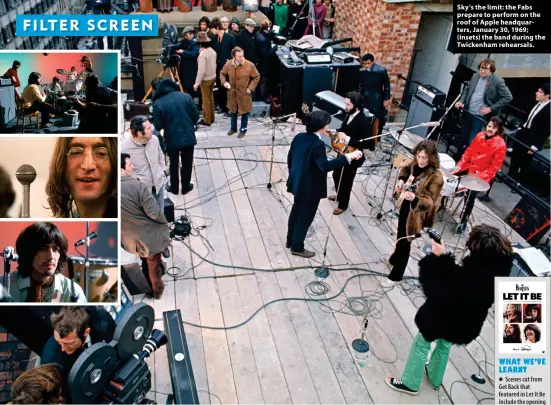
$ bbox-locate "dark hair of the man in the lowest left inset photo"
[15,222,69,277]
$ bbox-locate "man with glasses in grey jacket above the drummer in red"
[455,59,513,145]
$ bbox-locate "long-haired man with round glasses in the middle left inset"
[46,137,118,218]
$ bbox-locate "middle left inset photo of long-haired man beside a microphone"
[0,137,119,219]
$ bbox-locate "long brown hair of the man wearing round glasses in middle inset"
[46,137,119,218]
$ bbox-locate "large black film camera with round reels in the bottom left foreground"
[68,303,168,404]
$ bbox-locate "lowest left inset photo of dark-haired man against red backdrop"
[0,221,119,304]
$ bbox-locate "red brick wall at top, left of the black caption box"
[333,0,422,115]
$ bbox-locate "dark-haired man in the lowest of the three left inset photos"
[10,222,86,303]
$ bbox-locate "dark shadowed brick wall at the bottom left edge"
[0,326,31,403]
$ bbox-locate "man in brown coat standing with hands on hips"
[220,46,260,138]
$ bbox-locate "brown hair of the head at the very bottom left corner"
[11,364,65,404]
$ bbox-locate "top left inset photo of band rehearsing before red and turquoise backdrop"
[0,51,120,135]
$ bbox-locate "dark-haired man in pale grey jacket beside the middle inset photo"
[121,115,166,209]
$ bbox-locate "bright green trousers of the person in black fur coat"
[402,332,452,391]
